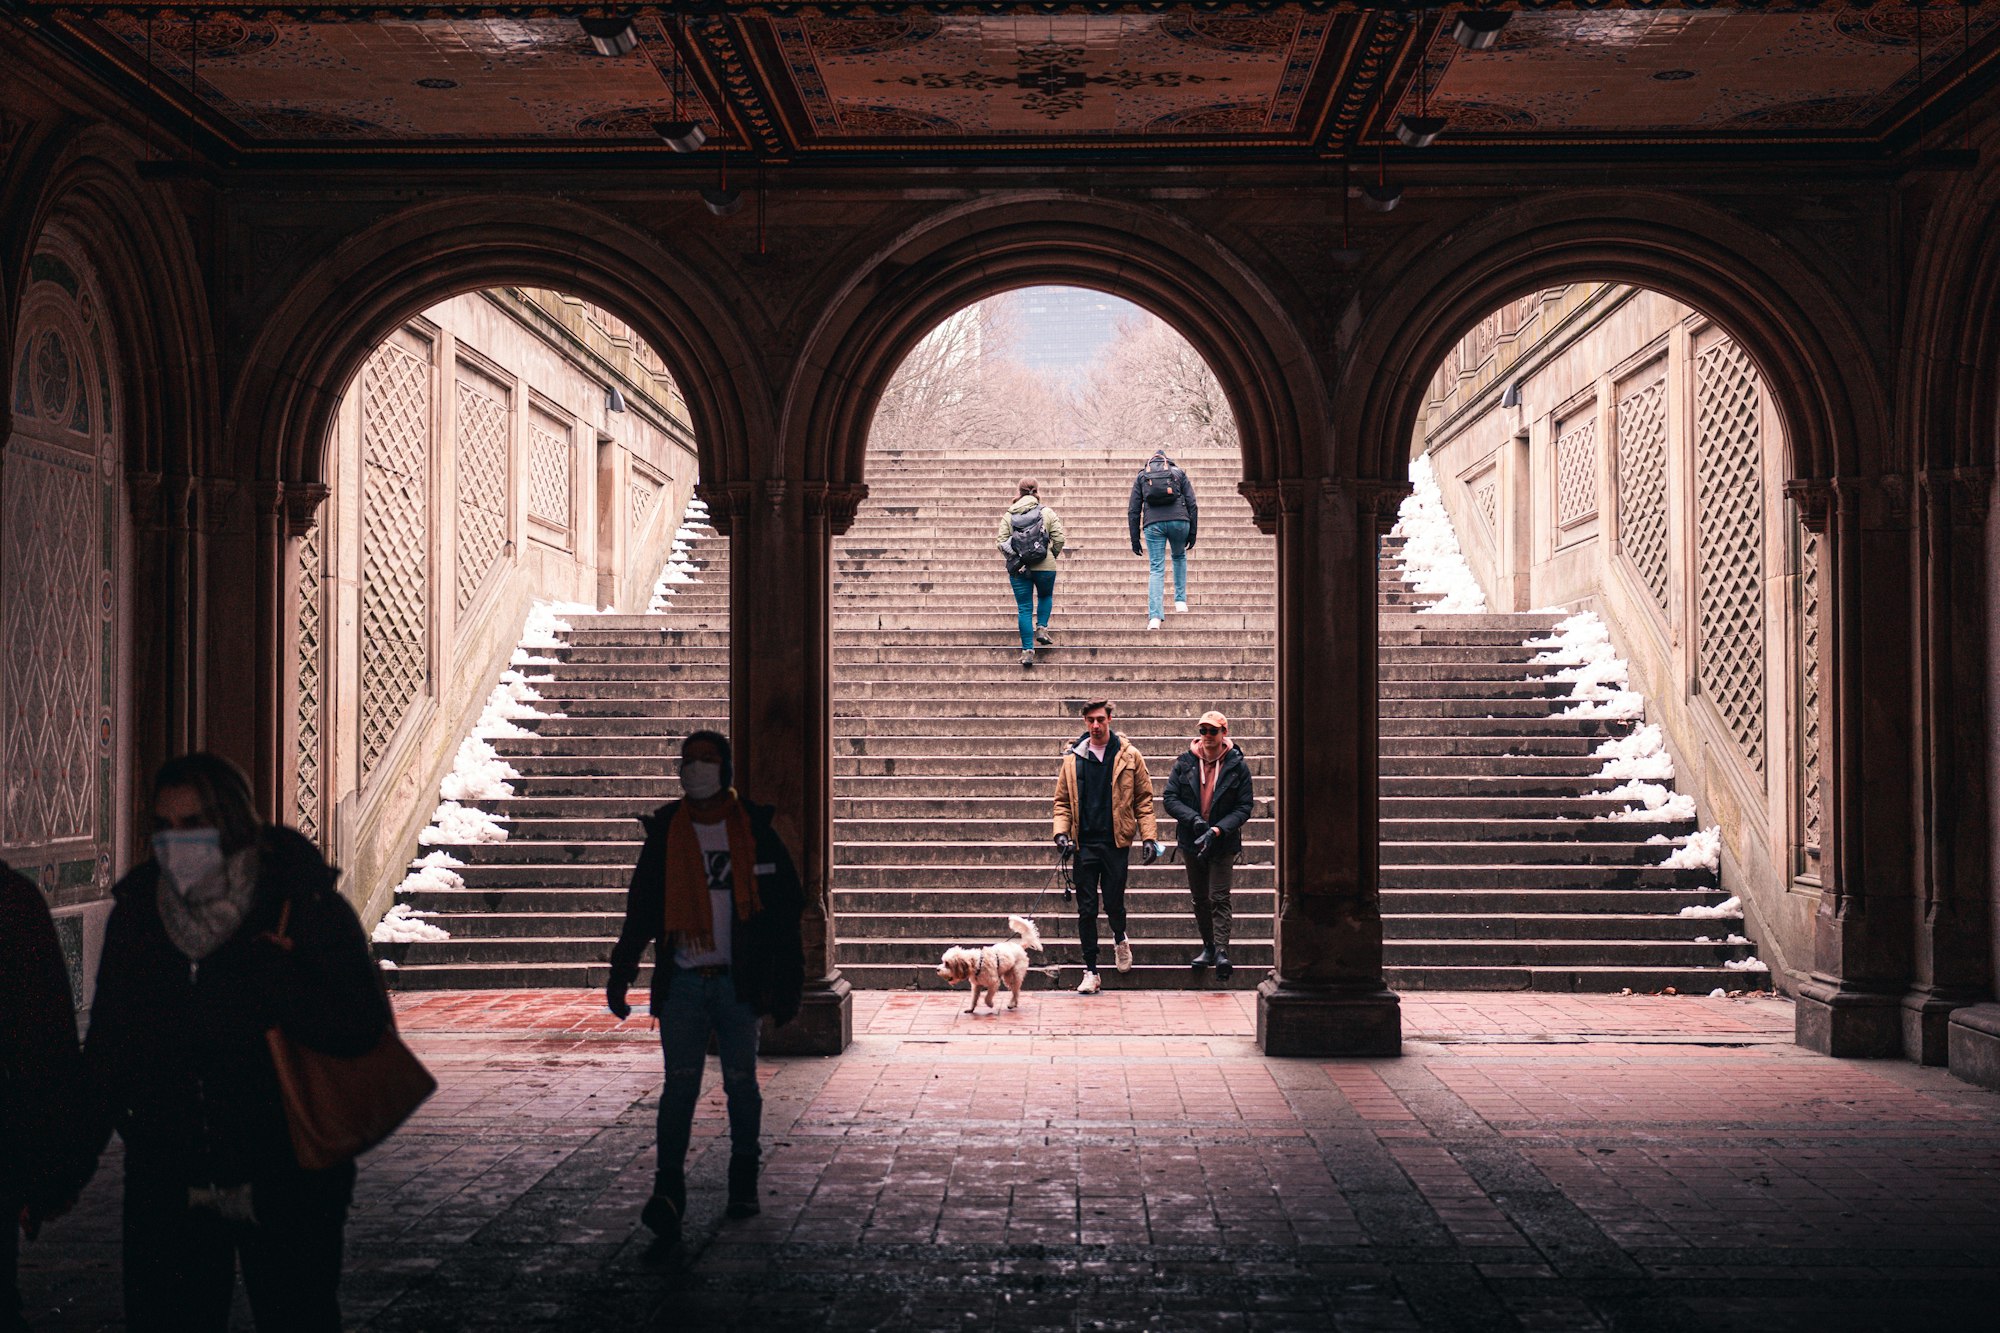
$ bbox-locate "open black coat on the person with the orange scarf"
[612,801,806,1027]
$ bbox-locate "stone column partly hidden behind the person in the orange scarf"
[696,480,866,1055]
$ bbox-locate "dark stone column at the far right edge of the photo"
[1902,468,1992,1065]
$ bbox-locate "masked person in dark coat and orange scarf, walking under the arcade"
[604,731,806,1245]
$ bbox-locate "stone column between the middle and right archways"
[1242,478,1408,1055]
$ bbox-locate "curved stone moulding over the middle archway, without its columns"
[784,194,1326,486]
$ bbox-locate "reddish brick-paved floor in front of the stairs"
[26,993,2000,1333]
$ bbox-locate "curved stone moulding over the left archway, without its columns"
[228,198,770,484]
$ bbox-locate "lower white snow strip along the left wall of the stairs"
[372,602,592,945]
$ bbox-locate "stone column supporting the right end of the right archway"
[1790,478,1914,1057]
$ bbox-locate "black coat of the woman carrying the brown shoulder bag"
[84,827,390,1185]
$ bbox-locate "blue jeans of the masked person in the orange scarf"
[654,961,764,1201]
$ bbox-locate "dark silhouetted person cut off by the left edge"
[0,861,92,1333]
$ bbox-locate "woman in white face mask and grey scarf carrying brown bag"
[84,755,390,1331]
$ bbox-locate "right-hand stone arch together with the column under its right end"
[1336,196,1912,1055]
